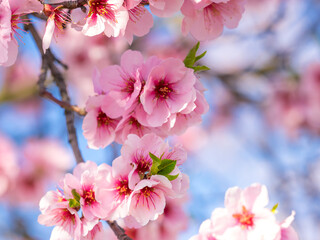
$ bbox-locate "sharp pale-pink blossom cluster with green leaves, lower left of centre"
[38,134,189,240]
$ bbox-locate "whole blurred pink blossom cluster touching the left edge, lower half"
[0,135,72,205]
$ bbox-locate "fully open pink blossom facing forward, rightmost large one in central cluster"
[140,58,196,127]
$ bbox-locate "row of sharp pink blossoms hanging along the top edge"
[0,0,248,66]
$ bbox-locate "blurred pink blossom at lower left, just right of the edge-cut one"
[8,139,73,204]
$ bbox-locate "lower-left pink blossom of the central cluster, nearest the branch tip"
[82,95,122,149]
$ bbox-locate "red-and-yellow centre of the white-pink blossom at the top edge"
[88,0,117,22]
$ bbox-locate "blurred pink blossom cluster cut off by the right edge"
[266,62,320,137]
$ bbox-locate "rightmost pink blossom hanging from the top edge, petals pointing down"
[181,0,245,41]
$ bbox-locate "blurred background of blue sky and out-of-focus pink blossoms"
[0,0,320,240]
